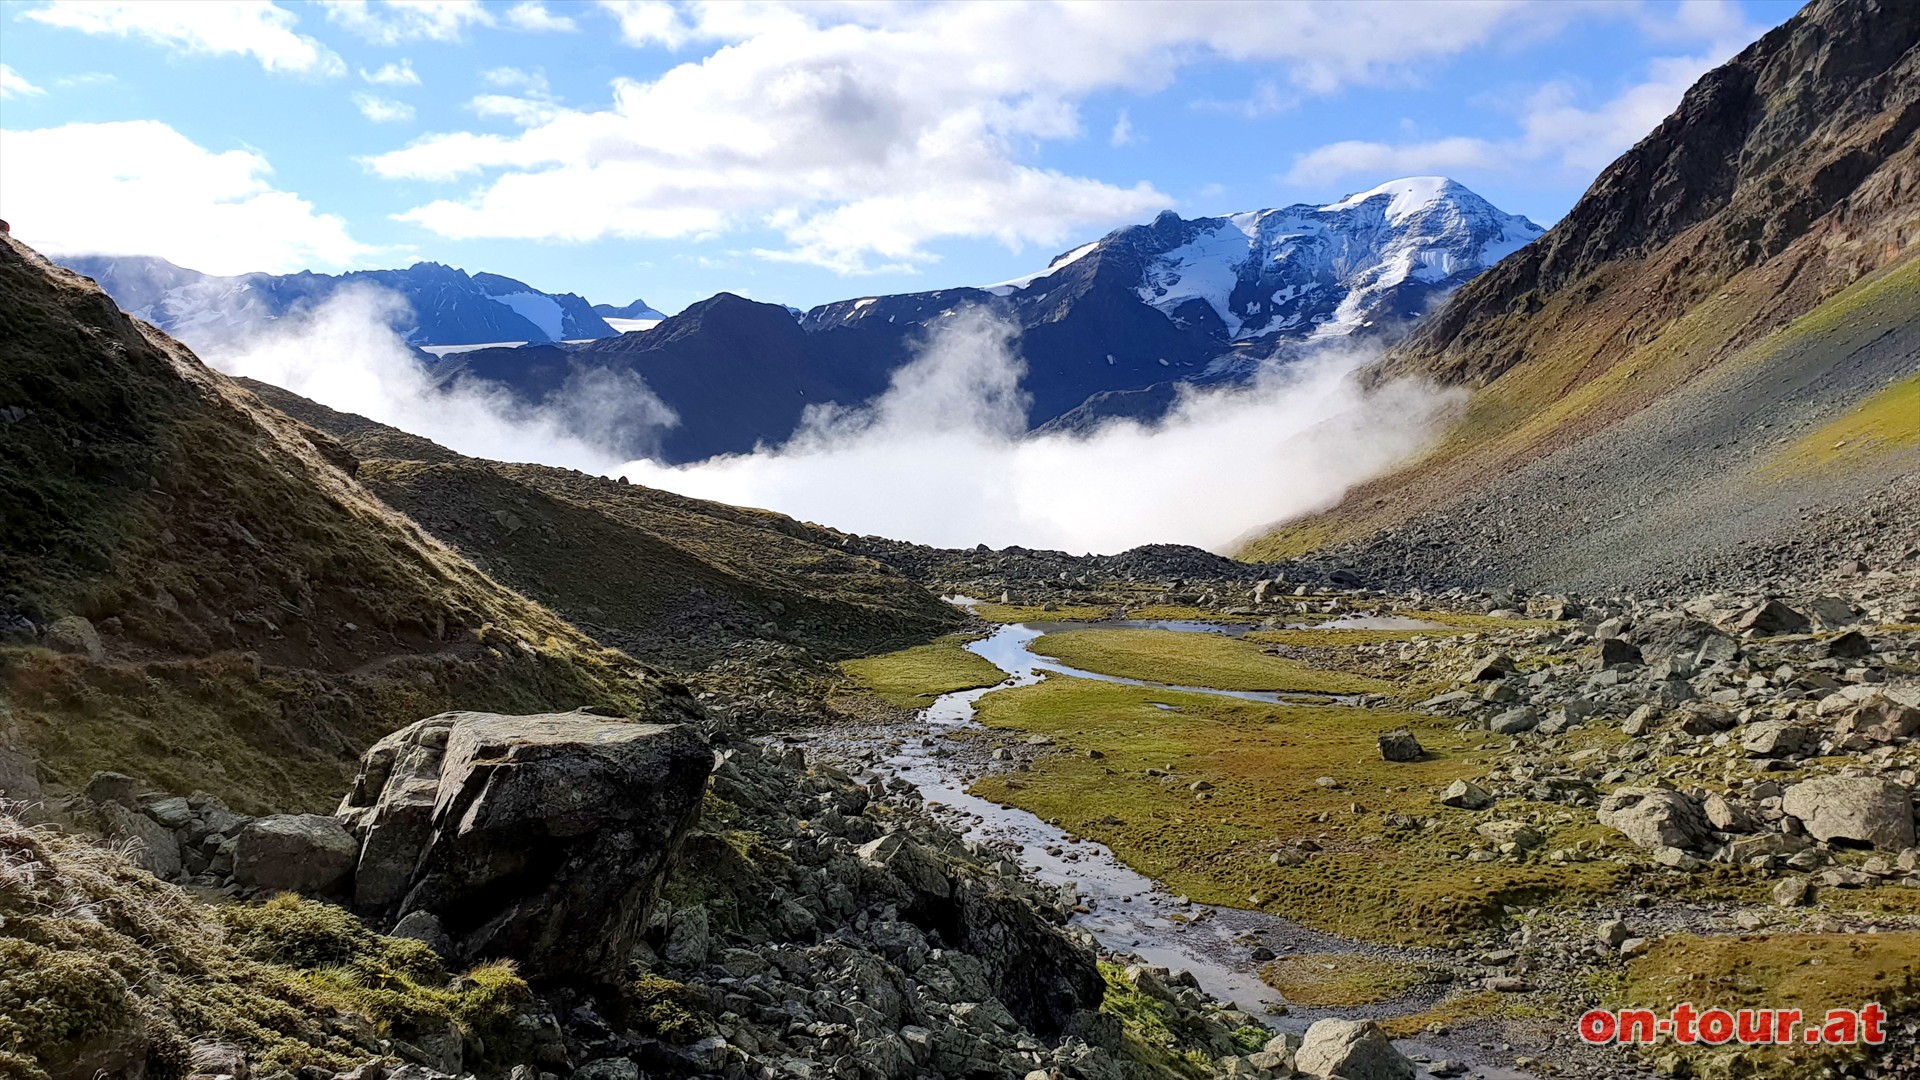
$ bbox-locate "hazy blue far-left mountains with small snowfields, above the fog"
[61,256,618,348]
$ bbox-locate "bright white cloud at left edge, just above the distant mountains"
[0,121,367,275]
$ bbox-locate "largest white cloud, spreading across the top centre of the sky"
[369,0,1563,273]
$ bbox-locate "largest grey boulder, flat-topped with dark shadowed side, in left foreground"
[340,711,714,984]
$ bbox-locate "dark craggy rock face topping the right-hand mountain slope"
[1402,0,1920,380]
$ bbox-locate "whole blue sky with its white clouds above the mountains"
[0,0,1795,311]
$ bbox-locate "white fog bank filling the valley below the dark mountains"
[196,288,1459,552]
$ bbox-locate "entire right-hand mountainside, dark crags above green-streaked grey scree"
[1242,2,1920,588]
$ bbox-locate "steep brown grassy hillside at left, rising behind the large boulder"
[0,238,691,809]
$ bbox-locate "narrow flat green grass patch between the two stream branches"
[1029,630,1392,694]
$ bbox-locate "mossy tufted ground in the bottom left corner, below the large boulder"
[0,817,530,1078]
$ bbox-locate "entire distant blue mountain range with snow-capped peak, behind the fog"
[69,177,1542,461]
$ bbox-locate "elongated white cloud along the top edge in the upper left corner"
[21,0,346,75]
